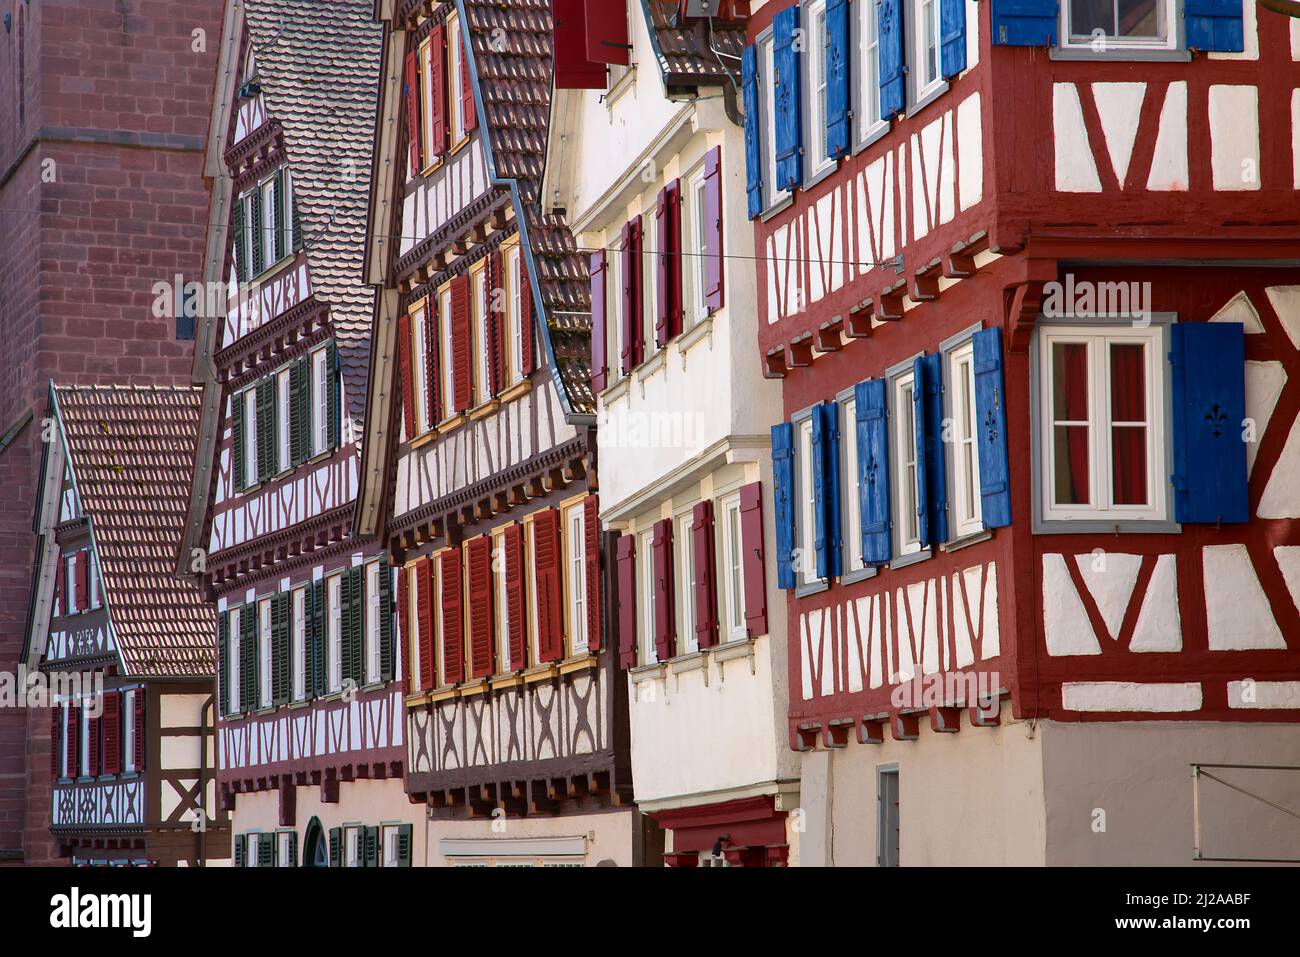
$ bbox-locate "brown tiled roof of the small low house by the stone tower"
[55,386,216,677]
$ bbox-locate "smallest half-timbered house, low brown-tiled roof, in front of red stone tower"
[22,386,230,866]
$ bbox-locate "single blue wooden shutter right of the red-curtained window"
[1170,322,1249,523]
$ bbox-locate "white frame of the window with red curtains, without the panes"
[1035,320,1171,527]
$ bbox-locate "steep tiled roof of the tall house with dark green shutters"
[243,0,384,421]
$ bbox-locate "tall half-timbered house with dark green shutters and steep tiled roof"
[178,0,423,866]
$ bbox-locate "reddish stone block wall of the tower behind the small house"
[0,0,224,863]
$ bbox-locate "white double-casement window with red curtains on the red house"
[1037,325,1169,521]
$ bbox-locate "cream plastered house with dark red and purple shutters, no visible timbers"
[542,0,798,866]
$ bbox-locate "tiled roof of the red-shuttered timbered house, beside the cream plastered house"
[464,0,595,415]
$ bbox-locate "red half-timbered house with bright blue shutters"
[744,0,1300,865]
